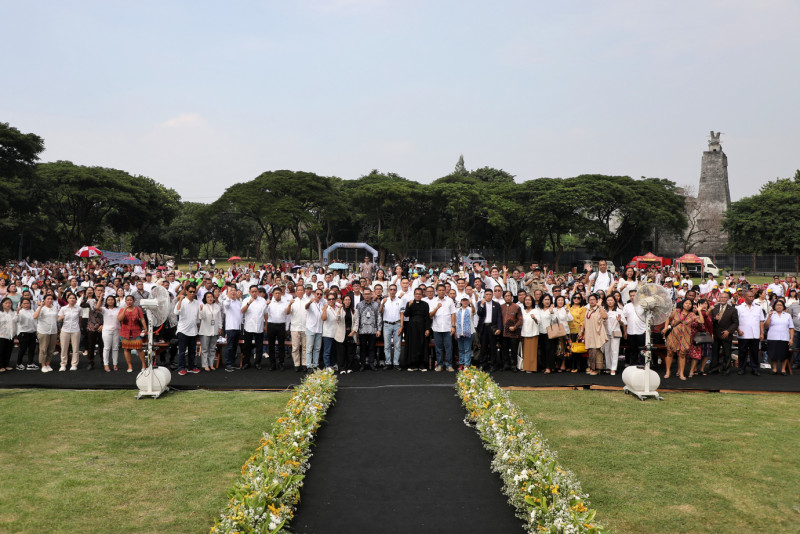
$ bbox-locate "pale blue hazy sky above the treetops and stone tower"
[0,0,800,202]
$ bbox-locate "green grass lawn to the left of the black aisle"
[0,390,290,533]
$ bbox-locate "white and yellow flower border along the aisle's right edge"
[457,369,608,533]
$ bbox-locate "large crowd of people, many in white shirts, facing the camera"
[0,257,800,380]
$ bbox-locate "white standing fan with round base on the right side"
[622,284,672,400]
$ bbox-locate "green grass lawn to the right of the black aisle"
[511,391,800,533]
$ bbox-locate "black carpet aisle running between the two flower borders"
[292,388,523,534]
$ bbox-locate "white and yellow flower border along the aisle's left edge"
[211,369,336,534]
